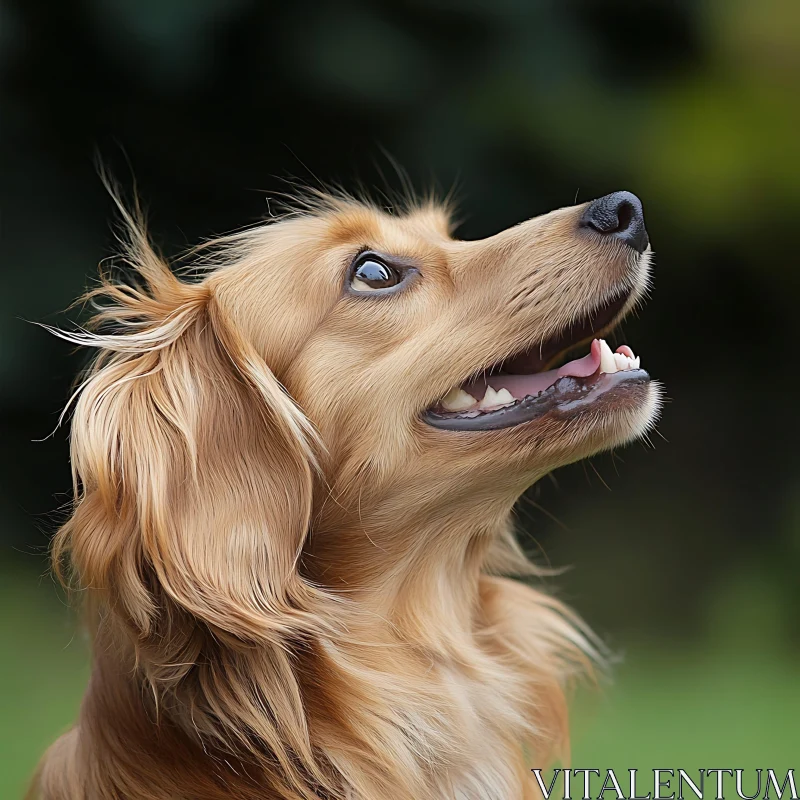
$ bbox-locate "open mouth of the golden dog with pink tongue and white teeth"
[422,292,650,431]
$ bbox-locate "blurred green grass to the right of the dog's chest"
[572,642,800,776]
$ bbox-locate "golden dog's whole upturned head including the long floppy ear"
[53,193,658,636]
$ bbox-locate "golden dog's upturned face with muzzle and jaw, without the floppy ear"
[210,192,658,523]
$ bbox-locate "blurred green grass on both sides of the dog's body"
[0,572,800,798]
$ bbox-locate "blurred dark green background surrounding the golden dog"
[0,0,800,798]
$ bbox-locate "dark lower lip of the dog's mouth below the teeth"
[422,369,650,431]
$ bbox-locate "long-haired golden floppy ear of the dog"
[55,219,324,646]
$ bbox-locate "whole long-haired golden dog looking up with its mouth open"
[31,192,659,800]
